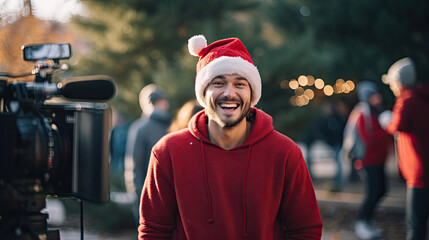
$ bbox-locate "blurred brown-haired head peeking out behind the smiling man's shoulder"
[168,100,204,133]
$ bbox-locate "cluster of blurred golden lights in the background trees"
[280,75,355,107]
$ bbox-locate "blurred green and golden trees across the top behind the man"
[0,0,429,138]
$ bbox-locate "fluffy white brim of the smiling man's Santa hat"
[195,56,262,108]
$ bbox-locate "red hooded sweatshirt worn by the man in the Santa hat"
[139,108,322,240]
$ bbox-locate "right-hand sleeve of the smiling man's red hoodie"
[281,147,322,239]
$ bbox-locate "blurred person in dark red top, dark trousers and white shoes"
[343,80,392,239]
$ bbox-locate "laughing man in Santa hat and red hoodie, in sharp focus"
[138,35,322,240]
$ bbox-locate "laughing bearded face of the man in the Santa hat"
[204,74,252,128]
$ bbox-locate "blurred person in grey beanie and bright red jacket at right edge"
[384,58,429,240]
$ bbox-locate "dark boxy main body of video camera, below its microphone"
[0,102,111,202]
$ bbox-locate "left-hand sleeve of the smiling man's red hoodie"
[138,153,178,240]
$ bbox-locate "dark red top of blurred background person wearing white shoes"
[357,109,392,167]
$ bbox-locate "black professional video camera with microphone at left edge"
[0,43,116,239]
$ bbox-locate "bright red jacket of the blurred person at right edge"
[387,85,429,188]
